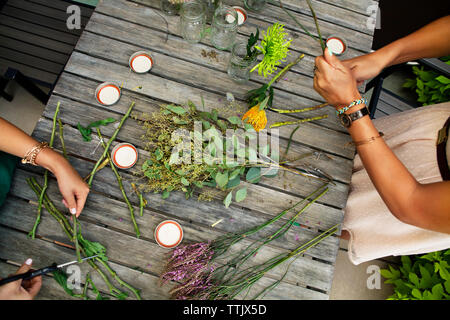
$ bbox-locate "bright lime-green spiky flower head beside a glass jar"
[251,23,292,78]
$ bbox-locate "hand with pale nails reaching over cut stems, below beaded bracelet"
[36,149,89,217]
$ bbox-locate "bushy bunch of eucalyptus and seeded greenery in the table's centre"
[137,102,278,207]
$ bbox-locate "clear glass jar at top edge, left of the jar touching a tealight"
[180,0,206,43]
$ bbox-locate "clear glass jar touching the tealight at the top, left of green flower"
[211,6,238,50]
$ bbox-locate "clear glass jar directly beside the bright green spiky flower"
[228,42,256,83]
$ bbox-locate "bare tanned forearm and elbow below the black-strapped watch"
[349,110,450,233]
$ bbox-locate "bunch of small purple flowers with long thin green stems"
[161,185,330,299]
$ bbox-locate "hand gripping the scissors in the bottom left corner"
[0,259,42,300]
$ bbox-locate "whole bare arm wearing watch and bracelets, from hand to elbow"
[314,49,450,233]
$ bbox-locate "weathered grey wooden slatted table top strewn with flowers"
[0,0,373,299]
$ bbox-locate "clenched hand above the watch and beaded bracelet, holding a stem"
[314,48,361,109]
